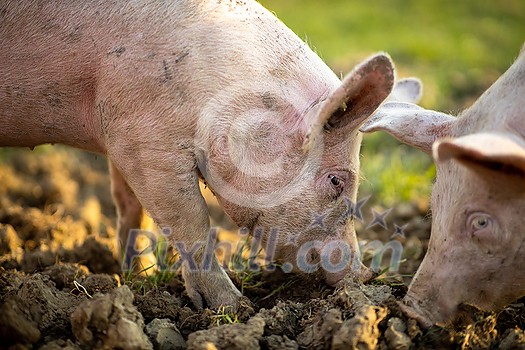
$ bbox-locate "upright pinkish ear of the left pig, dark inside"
[303,54,395,149]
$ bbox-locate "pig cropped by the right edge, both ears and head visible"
[362,43,525,326]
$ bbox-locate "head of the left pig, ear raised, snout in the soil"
[198,54,419,285]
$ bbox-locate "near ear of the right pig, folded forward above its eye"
[433,133,525,175]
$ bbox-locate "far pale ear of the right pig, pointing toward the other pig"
[360,102,456,154]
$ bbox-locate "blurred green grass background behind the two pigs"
[259,0,525,206]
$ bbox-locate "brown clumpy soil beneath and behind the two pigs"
[0,146,525,350]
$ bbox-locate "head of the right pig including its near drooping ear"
[412,131,525,326]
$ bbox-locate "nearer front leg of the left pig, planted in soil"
[108,145,241,308]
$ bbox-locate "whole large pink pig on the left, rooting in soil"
[0,0,414,307]
